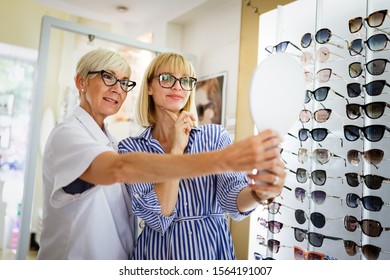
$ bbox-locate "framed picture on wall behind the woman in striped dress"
[195,72,227,124]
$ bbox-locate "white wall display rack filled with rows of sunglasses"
[248,0,390,260]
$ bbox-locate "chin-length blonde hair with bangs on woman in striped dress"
[137,53,198,127]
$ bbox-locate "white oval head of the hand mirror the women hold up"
[249,53,306,135]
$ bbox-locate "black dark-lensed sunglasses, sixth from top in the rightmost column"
[344,124,390,142]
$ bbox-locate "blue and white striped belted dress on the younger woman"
[119,124,251,260]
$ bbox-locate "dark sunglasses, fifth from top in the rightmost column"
[345,101,390,120]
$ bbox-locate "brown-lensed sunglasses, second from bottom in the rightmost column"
[344,215,390,237]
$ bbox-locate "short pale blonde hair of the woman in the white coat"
[76,49,131,80]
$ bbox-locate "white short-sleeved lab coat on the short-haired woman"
[38,107,136,260]
